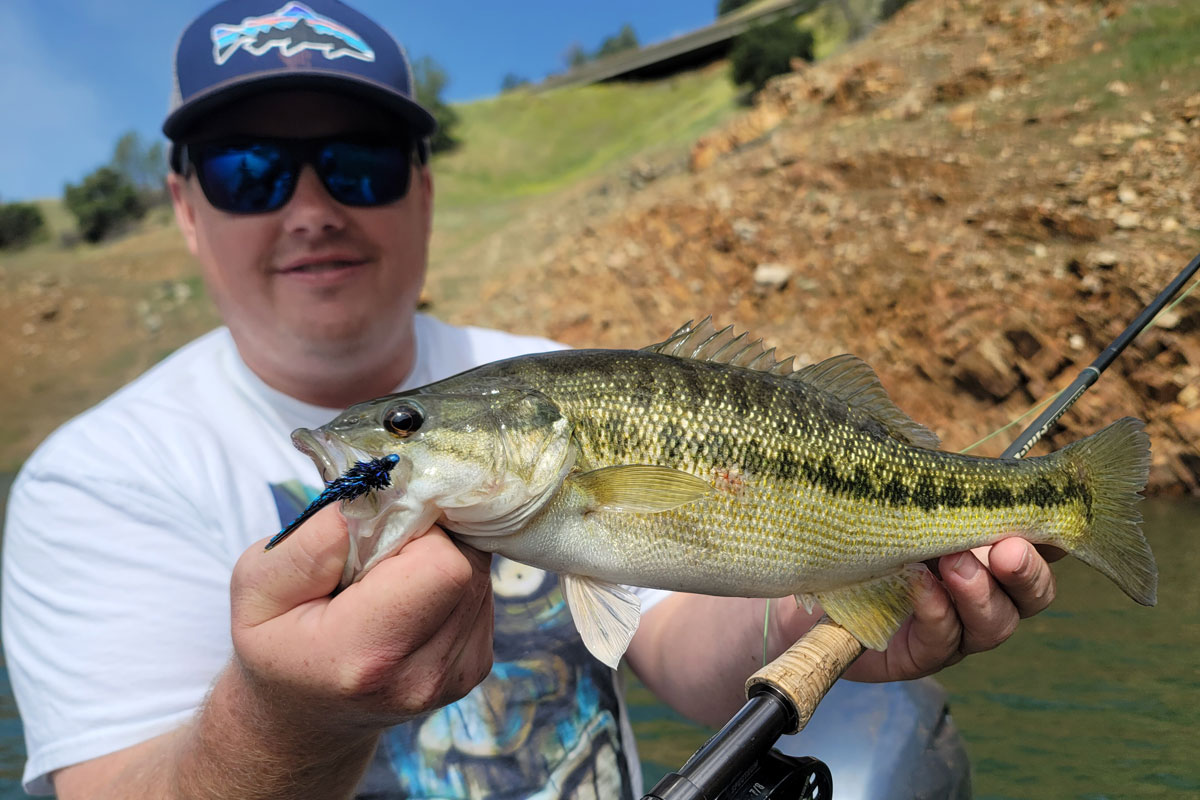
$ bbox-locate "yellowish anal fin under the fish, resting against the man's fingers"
[816,564,926,650]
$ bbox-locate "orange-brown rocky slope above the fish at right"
[457,0,1200,494]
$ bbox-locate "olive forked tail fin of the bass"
[1062,416,1158,606]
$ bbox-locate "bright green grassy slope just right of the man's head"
[430,62,740,302]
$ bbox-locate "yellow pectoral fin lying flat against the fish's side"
[568,464,713,513]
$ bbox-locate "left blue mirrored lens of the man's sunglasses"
[198,144,295,213]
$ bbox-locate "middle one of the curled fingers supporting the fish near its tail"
[938,552,1020,654]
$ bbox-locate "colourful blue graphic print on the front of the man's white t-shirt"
[271,481,632,800]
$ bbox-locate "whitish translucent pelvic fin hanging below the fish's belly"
[563,575,642,669]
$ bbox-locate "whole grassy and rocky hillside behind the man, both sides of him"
[0,0,1200,493]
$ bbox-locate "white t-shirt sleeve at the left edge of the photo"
[2,447,232,794]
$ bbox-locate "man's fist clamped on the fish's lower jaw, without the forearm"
[232,509,492,728]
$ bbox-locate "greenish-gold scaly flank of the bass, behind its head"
[484,351,1082,594]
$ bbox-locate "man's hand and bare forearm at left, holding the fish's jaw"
[54,507,492,800]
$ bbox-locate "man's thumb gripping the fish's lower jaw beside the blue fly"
[230,506,350,626]
